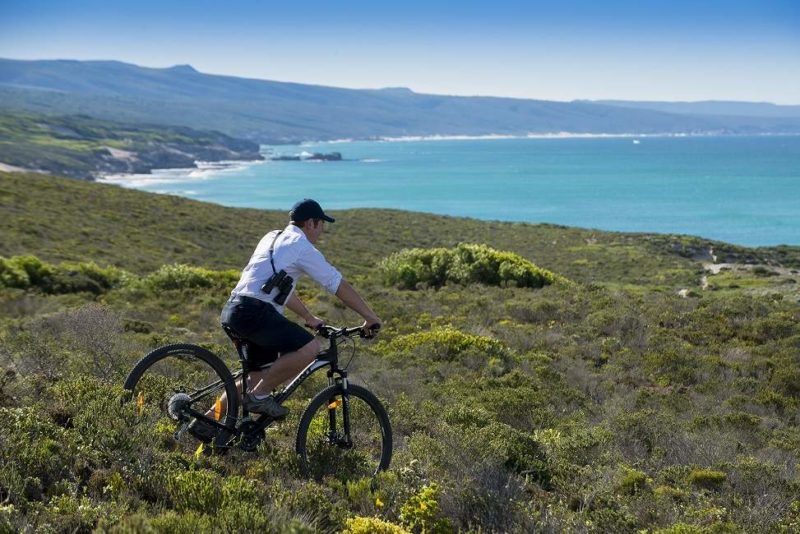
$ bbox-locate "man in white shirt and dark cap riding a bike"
[189,198,381,441]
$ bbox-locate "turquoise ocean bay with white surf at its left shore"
[100,136,800,246]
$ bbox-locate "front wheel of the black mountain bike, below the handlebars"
[296,384,392,480]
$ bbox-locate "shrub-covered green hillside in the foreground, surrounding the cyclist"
[0,173,800,534]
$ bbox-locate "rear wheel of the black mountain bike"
[124,343,239,449]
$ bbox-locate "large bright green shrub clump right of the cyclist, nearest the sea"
[380,243,565,289]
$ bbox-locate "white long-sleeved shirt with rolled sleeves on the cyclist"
[231,224,342,313]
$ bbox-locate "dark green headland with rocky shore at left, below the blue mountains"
[0,111,263,179]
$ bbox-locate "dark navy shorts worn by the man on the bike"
[219,295,314,367]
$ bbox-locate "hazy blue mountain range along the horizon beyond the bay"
[0,59,800,143]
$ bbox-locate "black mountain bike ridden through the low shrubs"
[124,325,392,484]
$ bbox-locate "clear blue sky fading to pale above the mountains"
[0,0,800,105]
